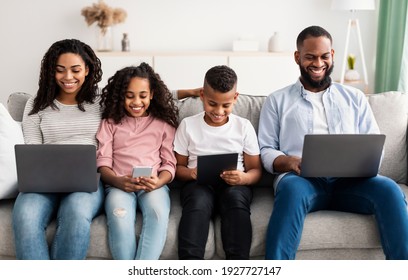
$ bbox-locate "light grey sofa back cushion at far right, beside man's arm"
[368,92,408,184]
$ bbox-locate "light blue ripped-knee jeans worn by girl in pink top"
[105,185,170,260]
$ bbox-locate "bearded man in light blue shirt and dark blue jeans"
[258,26,408,259]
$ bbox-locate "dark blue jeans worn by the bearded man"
[265,173,408,259]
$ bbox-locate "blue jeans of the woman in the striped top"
[13,183,104,260]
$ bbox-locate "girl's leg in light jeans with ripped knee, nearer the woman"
[105,187,137,260]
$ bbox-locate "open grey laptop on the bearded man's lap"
[300,134,385,177]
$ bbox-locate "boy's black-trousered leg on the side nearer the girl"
[178,182,214,260]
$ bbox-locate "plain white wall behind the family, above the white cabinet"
[0,0,378,104]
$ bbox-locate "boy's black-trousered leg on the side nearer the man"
[219,186,252,260]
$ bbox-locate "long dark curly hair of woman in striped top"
[30,39,102,115]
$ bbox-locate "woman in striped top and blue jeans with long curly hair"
[13,39,104,259]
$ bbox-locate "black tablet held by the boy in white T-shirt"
[197,153,238,185]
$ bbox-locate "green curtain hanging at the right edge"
[375,0,408,93]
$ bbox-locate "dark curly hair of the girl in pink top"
[100,62,178,127]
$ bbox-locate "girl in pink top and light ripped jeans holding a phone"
[97,63,178,259]
